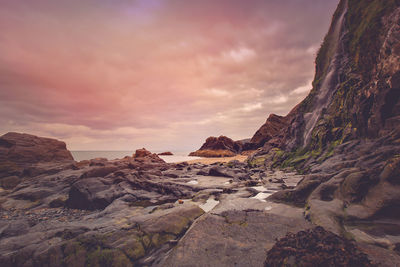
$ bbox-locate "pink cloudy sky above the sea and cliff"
[0,0,339,151]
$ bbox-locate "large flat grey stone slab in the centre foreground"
[154,198,312,266]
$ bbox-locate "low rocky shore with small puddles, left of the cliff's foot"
[0,133,400,266]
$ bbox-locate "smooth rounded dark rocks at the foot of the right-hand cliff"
[260,132,400,266]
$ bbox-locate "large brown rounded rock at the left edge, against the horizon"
[0,132,74,165]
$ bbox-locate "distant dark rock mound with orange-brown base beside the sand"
[189,135,243,157]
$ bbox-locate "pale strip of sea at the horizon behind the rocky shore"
[71,151,200,163]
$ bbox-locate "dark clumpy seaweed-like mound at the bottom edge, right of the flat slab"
[265,227,374,267]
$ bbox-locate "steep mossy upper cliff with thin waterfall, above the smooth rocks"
[252,0,400,164]
